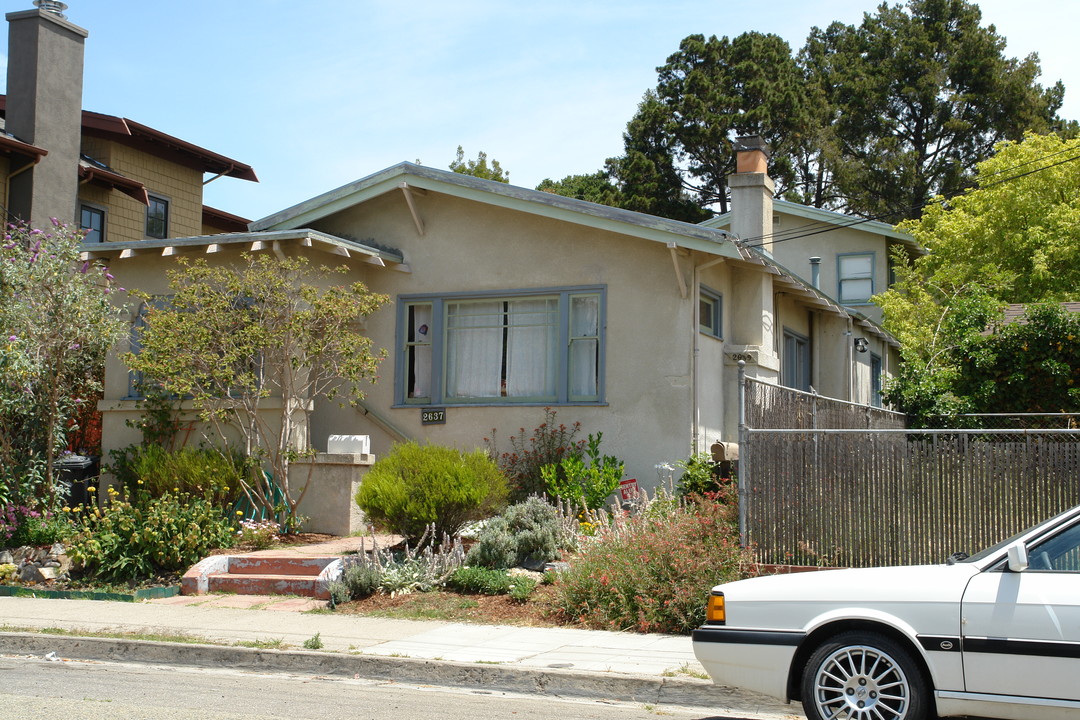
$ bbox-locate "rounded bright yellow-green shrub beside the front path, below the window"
[356,443,507,541]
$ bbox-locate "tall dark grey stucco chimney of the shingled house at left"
[5,0,90,228]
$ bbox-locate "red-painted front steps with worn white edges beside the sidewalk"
[180,555,342,600]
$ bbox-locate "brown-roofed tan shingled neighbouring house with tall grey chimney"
[0,3,257,243]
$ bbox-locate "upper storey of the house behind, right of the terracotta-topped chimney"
[702,179,924,323]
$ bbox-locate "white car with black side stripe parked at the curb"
[693,507,1080,720]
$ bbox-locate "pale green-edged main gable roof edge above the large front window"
[251,162,740,258]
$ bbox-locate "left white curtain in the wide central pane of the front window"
[446,301,503,397]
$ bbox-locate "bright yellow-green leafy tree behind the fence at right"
[877,134,1080,417]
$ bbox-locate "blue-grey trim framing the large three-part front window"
[394,285,607,408]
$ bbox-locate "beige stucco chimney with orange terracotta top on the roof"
[728,135,777,254]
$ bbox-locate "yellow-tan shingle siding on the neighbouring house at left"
[79,138,203,242]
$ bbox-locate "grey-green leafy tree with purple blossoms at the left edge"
[0,222,124,501]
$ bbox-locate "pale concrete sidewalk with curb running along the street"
[0,596,801,718]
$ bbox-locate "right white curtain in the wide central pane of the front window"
[507,298,558,398]
